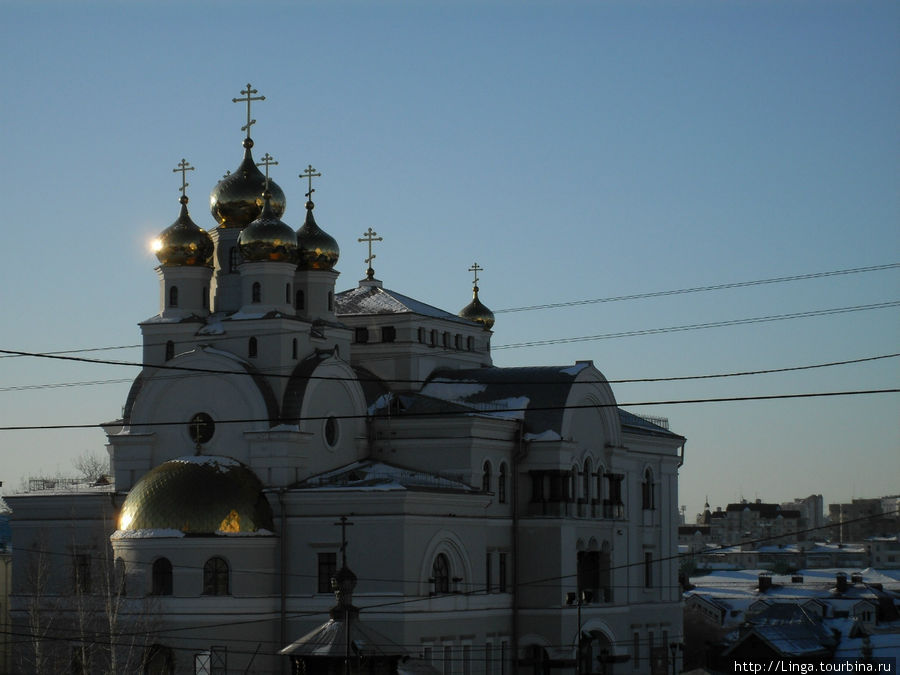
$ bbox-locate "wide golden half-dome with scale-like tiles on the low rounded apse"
[119,456,274,534]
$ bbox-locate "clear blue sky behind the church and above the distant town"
[0,0,900,518]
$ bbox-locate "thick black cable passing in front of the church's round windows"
[0,388,900,431]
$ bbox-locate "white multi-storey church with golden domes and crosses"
[6,85,685,675]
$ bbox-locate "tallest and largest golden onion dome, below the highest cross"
[209,138,285,228]
